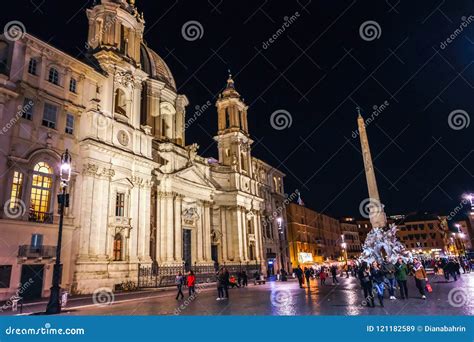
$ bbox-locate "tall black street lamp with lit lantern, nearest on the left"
[46,149,72,314]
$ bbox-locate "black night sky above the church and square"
[0,0,474,216]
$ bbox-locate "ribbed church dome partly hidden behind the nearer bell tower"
[140,44,176,90]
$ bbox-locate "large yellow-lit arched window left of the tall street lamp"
[29,162,53,223]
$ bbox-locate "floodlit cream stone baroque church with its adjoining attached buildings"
[0,0,289,299]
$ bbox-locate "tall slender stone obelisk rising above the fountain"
[357,107,387,228]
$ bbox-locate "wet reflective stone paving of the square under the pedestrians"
[50,273,474,315]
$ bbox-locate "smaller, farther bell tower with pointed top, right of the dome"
[214,73,253,177]
